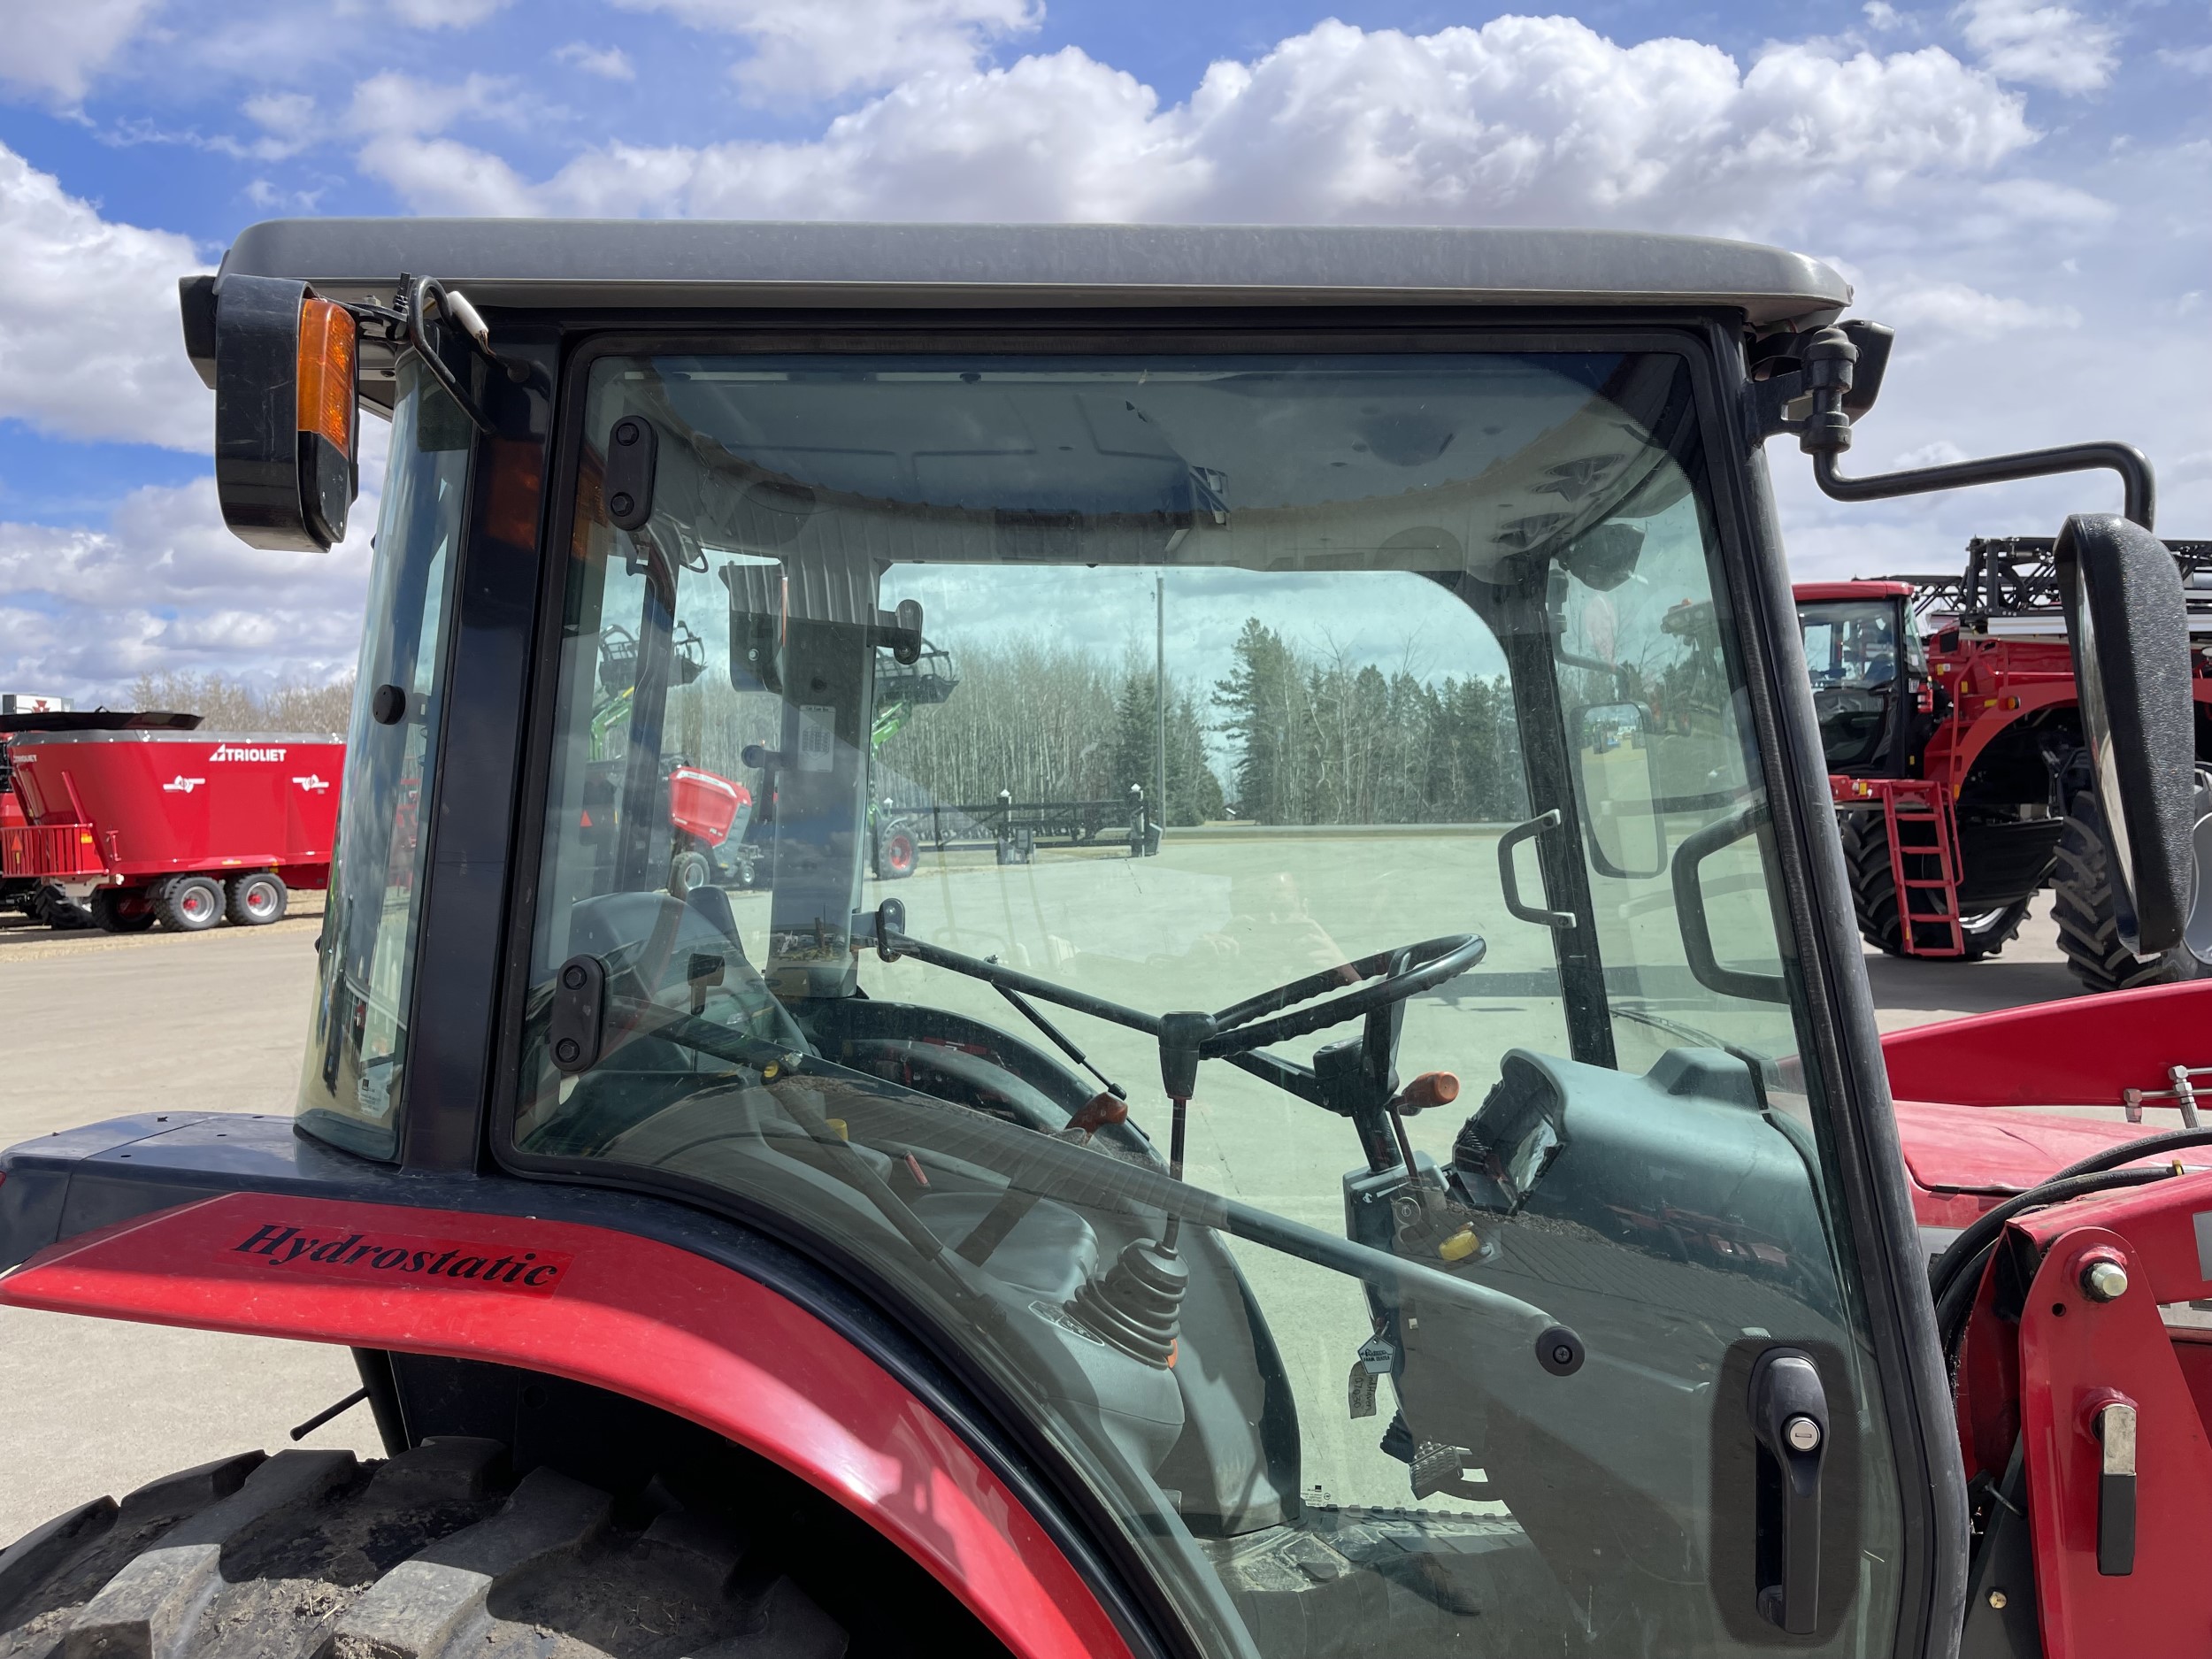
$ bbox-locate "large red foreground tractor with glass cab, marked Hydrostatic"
[0,219,2212,1659]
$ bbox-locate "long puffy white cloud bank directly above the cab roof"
[363,18,2035,233]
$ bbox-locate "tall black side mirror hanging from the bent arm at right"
[2051,513,2197,956]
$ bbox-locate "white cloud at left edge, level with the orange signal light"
[0,144,215,449]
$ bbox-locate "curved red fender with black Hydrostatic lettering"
[0,1193,1131,1659]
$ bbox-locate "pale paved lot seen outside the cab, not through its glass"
[0,885,2073,1544]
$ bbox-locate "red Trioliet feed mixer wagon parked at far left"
[0,730,345,933]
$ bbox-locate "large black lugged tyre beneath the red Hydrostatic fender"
[0,1438,849,1659]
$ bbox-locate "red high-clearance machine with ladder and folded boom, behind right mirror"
[1796,535,2212,991]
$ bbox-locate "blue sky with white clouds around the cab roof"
[0,0,2212,699]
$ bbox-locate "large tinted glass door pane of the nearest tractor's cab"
[511,352,1893,1655]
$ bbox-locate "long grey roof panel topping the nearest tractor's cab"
[224,219,1852,323]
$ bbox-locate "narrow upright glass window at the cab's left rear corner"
[299,358,472,1157]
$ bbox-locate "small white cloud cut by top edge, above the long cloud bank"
[615,0,1044,102]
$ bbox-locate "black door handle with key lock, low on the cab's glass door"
[1750,1348,1827,1637]
